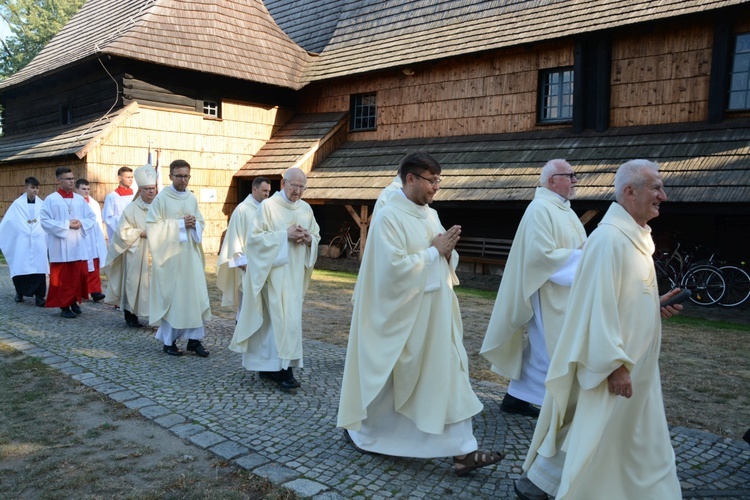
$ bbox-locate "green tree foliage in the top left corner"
[0,0,86,78]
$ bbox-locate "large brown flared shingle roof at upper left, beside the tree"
[0,0,309,89]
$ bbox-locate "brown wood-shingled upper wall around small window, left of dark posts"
[300,41,574,140]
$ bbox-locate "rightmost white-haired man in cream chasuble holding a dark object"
[515,160,682,500]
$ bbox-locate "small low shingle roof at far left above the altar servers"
[0,103,138,163]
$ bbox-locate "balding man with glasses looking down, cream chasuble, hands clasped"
[229,168,320,391]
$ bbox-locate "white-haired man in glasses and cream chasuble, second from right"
[481,160,586,417]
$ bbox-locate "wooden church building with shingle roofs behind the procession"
[0,0,750,259]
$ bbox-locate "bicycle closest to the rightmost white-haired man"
[654,243,726,306]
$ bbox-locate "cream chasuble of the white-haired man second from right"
[481,187,586,379]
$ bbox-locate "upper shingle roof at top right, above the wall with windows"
[302,0,747,81]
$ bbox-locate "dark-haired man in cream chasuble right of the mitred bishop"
[146,160,211,357]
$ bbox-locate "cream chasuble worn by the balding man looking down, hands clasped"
[229,191,320,370]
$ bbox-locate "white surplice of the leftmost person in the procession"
[0,193,49,278]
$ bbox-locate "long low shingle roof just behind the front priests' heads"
[305,119,750,203]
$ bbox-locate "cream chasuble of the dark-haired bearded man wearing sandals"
[337,195,482,440]
